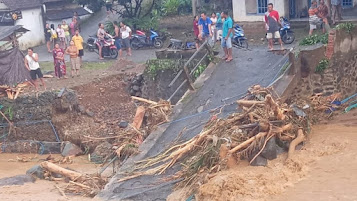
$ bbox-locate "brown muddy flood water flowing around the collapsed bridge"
[0,112,357,201]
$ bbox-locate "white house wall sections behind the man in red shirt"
[233,0,289,22]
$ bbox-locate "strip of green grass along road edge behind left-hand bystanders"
[40,61,114,72]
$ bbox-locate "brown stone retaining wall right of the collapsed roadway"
[289,29,357,102]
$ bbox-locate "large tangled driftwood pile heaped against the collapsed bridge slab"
[120,86,308,189]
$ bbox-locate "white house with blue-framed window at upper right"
[232,0,357,22]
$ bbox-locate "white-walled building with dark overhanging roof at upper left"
[0,0,91,49]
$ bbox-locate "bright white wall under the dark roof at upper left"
[15,8,45,49]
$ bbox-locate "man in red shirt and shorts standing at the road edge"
[265,3,284,50]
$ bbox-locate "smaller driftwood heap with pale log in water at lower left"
[41,161,107,197]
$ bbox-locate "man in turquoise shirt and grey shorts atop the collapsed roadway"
[221,11,233,62]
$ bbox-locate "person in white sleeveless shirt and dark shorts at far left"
[25,48,46,91]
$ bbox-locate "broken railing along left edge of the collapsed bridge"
[168,40,213,101]
